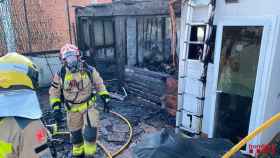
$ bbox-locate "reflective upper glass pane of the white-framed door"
[218,26,263,97]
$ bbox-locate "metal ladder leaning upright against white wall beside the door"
[176,0,216,135]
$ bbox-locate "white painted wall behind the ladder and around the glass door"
[180,0,280,143]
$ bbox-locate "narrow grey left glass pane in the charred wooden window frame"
[93,20,104,46]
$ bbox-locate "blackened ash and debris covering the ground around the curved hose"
[38,89,175,158]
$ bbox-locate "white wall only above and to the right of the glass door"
[215,0,280,148]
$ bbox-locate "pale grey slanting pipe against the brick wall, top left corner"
[0,0,17,52]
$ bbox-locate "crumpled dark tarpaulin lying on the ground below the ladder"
[133,129,245,158]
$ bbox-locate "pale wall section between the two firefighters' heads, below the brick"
[29,54,61,87]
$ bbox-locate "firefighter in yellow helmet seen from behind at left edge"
[0,53,51,158]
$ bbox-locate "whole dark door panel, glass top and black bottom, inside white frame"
[214,26,263,143]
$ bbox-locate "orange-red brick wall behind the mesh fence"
[0,0,112,53]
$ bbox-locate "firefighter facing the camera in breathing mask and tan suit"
[49,44,110,158]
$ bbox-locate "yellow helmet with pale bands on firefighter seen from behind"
[0,53,39,89]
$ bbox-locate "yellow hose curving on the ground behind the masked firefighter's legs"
[46,108,133,158]
